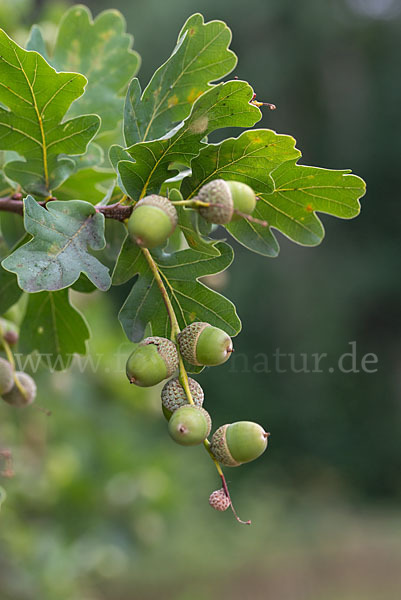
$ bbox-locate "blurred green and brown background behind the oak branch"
[0,0,401,600]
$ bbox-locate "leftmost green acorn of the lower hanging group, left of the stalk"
[126,336,178,387]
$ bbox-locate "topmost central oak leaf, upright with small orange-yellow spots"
[124,14,237,146]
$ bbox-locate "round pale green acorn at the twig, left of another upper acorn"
[127,194,178,248]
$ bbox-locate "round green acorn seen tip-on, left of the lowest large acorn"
[168,404,212,446]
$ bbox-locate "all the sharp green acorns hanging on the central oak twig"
[126,179,269,511]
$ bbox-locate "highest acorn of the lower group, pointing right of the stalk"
[178,321,233,367]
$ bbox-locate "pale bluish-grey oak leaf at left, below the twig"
[2,196,110,292]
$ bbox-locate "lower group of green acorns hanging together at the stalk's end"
[126,322,269,510]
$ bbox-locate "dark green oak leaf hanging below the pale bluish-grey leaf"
[18,289,90,371]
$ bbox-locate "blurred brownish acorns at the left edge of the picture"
[0,319,36,407]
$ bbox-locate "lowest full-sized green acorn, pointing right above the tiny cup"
[210,421,270,467]
